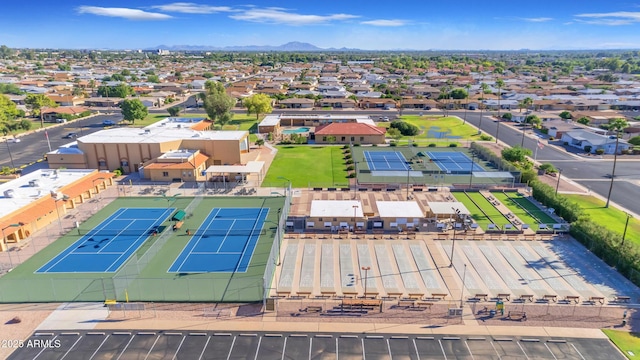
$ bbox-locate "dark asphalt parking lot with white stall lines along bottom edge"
[9,331,624,360]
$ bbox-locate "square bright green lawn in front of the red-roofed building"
[263,145,349,188]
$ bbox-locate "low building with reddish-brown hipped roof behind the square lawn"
[315,123,387,144]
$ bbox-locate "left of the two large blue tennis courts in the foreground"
[36,208,175,274]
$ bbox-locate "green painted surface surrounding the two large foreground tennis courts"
[0,197,284,303]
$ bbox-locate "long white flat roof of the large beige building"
[78,126,248,144]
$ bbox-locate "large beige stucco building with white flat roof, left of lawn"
[47,119,249,176]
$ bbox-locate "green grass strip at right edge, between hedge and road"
[563,195,640,246]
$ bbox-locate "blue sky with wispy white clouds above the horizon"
[0,0,640,50]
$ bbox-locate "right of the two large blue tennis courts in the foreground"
[168,208,269,273]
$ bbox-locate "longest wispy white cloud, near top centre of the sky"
[230,8,358,25]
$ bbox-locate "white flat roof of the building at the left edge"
[0,169,95,218]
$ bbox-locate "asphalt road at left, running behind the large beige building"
[0,113,122,171]
